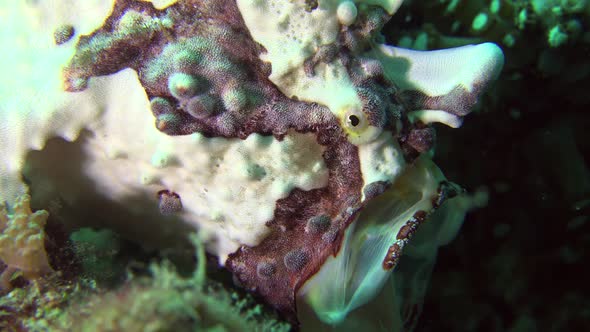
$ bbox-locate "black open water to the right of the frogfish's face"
[387,1,590,331]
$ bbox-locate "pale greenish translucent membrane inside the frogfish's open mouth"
[298,157,446,324]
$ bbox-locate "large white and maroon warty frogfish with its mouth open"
[0,0,503,323]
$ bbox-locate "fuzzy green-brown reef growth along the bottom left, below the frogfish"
[0,231,291,332]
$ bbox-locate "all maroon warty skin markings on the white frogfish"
[64,0,502,320]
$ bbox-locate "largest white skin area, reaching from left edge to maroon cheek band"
[0,0,328,262]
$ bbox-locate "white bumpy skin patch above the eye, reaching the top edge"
[237,0,362,123]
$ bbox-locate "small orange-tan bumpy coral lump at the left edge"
[0,195,53,290]
